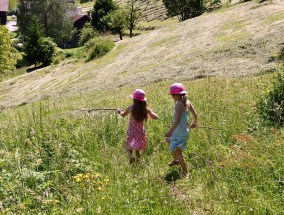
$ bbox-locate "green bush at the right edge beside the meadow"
[257,67,284,126]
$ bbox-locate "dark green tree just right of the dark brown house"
[91,0,117,32]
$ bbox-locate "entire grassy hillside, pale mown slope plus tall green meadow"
[0,1,284,215]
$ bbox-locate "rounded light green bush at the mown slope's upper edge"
[86,37,114,61]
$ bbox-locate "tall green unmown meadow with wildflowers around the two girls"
[0,74,284,214]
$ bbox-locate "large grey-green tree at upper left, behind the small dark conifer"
[18,0,75,45]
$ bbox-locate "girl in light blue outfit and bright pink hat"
[165,83,197,176]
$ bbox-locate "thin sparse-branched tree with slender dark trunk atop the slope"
[126,0,153,37]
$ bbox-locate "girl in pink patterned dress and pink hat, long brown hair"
[117,89,158,164]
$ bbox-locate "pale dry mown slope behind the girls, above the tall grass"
[0,0,284,109]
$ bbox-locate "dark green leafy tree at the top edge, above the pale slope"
[163,0,204,21]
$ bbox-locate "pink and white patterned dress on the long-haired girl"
[126,112,147,151]
